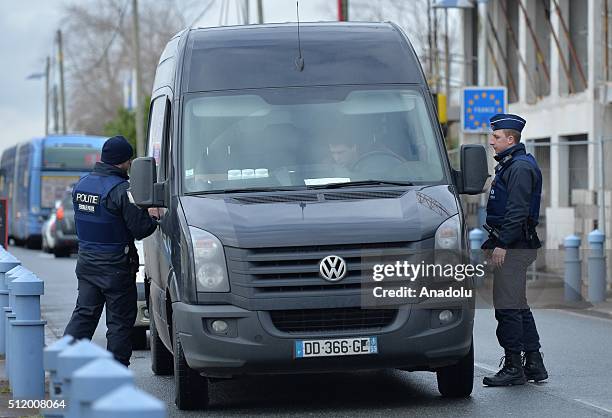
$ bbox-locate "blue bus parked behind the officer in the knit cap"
[0,135,106,247]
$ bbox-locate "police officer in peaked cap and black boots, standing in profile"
[483,114,548,386]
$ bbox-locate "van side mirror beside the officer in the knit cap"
[129,157,166,208]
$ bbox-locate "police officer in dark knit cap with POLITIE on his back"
[64,136,157,366]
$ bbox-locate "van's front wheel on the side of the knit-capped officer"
[172,320,208,411]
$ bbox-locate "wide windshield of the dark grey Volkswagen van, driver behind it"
[182,86,444,193]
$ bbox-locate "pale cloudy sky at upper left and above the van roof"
[0,0,336,152]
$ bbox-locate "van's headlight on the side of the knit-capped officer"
[189,226,230,292]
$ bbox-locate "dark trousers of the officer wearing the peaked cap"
[493,249,540,353]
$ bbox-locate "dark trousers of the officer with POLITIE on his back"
[64,270,137,366]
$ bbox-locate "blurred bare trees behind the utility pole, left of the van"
[62,0,194,134]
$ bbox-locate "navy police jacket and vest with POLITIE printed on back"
[72,162,157,275]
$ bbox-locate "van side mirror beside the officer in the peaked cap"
[456,144,489,195]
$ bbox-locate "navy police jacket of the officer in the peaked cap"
[487,143,542,248]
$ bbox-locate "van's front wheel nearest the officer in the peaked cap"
[436,341,474,398]
